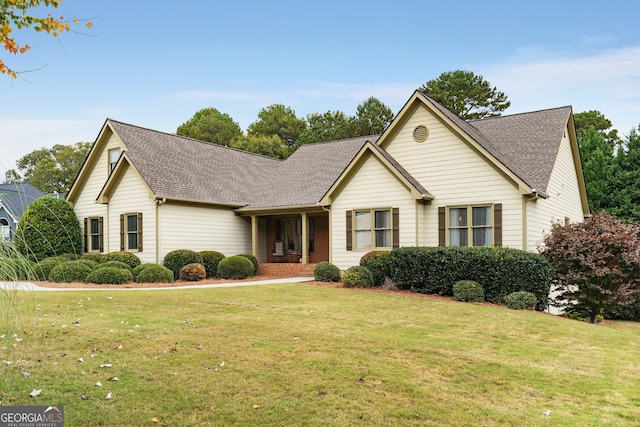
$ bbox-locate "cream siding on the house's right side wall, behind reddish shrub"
[527,131,584,251]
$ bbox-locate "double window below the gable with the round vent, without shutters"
[447,205,493,246]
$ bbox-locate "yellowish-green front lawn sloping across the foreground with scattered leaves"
[0,284,640,426]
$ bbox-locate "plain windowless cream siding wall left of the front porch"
[158,203,251,262]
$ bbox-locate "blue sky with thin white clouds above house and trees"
[0,0,640,180]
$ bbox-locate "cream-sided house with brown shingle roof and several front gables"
[67,91,589,269]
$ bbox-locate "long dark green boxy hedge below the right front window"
[389,247,556,310]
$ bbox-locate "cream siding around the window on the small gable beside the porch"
[331,156,416,270]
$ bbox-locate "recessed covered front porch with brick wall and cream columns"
[241,207,330,265]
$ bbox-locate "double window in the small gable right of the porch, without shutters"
[354,209,392,249]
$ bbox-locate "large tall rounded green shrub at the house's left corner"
[15,196,82,261]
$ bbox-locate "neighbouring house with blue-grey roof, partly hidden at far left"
[0,183,46,242]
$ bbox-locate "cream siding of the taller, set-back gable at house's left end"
[73,134,124,247]
